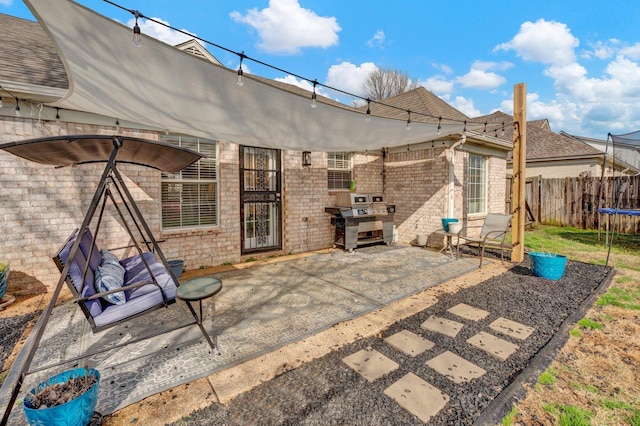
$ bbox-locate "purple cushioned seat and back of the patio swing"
[53,229,177,333]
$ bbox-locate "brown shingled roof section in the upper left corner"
[0,14,69,89]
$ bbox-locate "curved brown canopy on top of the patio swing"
[0,135,202,173]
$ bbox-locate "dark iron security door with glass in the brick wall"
[240,146,282,254]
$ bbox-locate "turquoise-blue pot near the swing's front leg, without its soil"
[22,368,100,426]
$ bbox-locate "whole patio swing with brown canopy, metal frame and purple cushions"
[0,135,216,424]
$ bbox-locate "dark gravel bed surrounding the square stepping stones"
[168,256,611,425]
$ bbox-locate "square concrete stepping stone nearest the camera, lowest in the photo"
[384,373,449,423]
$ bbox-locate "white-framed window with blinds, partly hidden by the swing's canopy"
[160,134,219,229]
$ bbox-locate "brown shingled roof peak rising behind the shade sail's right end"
[358,86,470,123]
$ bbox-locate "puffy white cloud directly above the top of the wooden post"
[494,19,579,66]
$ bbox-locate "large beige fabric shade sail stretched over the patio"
[24,0,473,151]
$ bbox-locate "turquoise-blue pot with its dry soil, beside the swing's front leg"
[22,368,100,426]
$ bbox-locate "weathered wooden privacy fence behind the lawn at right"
[506,176,640,234]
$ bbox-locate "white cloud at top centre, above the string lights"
[230,0,342,54]
